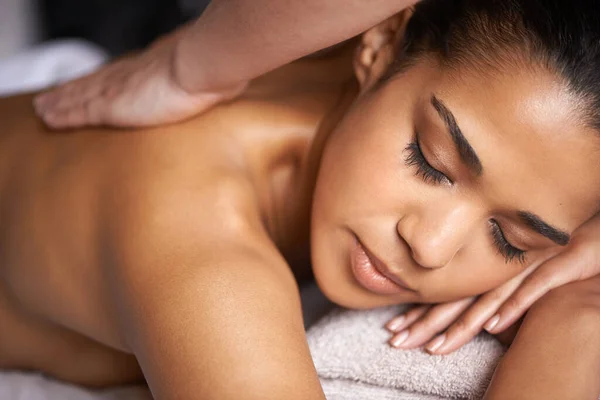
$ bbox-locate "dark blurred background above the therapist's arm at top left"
[0,0,210,56]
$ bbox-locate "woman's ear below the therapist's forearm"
[354,10,412,93]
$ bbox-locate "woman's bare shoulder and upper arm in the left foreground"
[98,162,322,399]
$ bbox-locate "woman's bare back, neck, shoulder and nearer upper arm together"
[0,52,352,399]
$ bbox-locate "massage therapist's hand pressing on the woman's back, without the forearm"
[34,29,245,129]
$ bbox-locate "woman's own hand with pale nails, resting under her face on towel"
[386,214,600,354]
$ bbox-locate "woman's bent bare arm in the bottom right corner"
[485,277,600,400]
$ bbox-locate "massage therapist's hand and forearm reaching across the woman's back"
[35,0,416,129]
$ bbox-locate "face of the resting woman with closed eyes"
[311,54,600,308]
